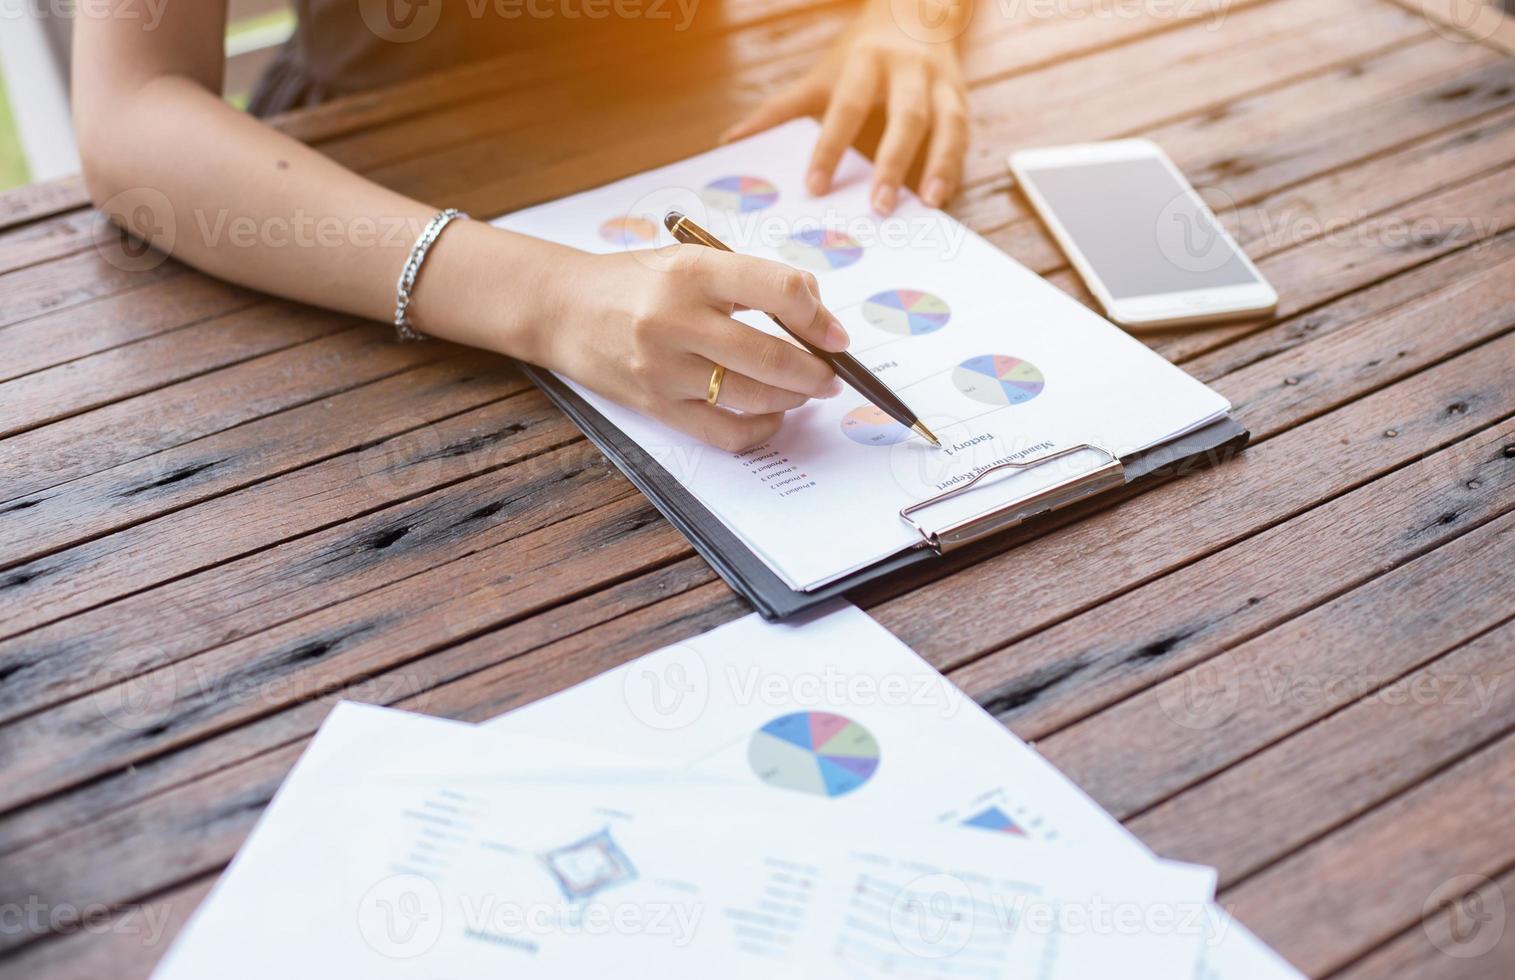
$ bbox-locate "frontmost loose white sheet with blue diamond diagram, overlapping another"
[155,704,1214,980]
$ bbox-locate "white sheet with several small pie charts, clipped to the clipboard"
[497,120,1229,591]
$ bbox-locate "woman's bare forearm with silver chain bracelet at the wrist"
[82,76,556,359]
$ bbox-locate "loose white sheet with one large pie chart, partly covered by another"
[485,604,1300,980]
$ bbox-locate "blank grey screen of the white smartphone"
[1023,158,1257,300]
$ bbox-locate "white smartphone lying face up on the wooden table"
[1011,139,1279,330]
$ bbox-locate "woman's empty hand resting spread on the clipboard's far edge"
[721,0,968,214]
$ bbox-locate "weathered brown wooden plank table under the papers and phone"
[0,0,1515,977]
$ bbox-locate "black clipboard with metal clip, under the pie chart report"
[521,364,1250,621]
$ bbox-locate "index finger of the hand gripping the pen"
[692,248,850,354]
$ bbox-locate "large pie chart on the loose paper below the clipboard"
[747,712,879,797]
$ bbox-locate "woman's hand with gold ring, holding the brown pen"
[539,245,847,451]
